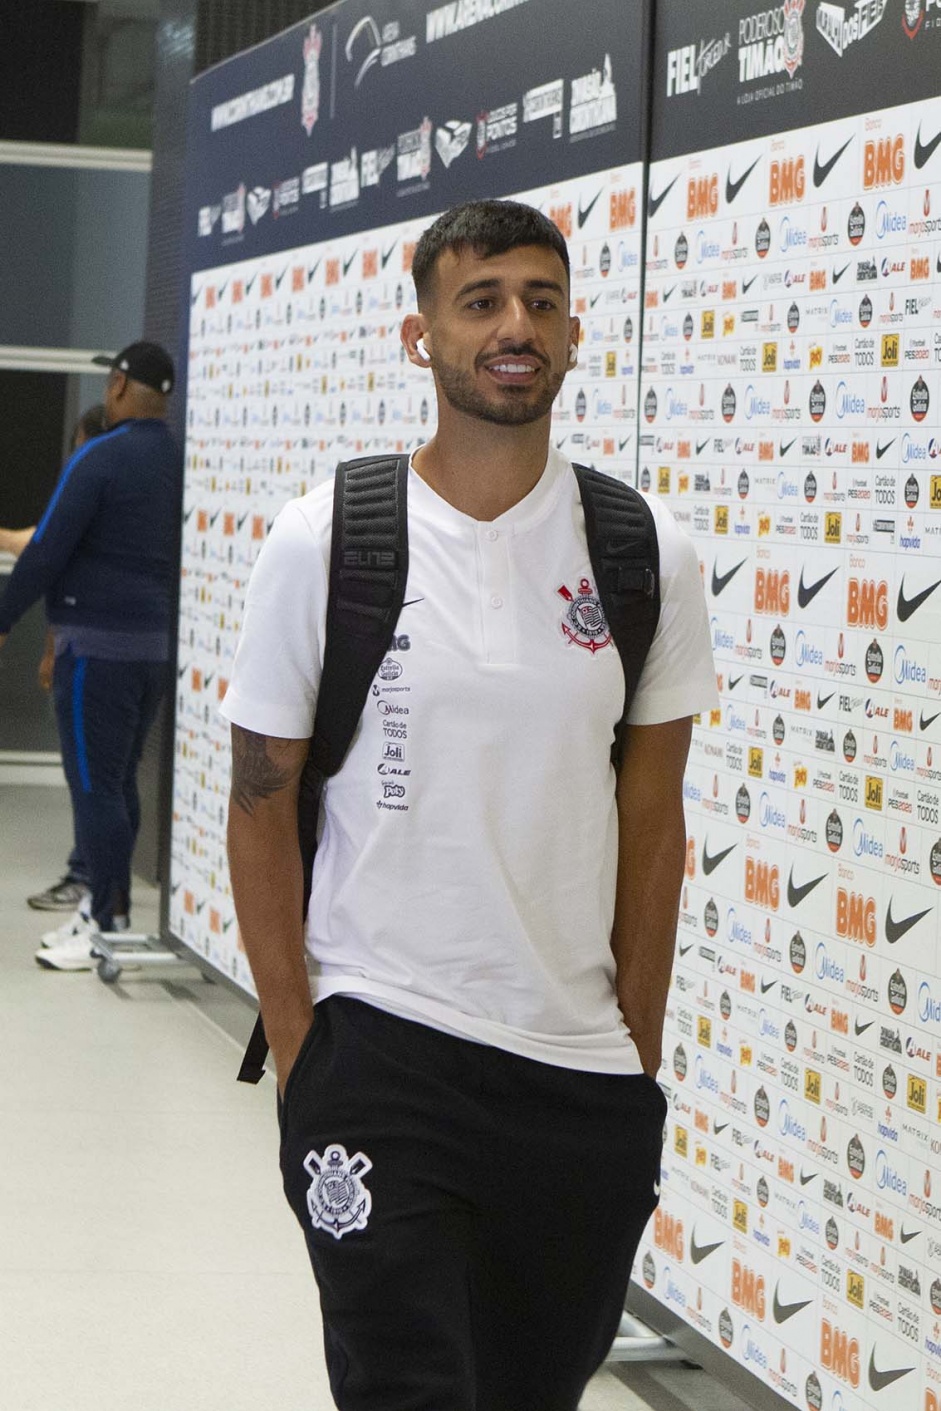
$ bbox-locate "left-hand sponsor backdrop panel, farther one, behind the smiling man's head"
[168,0,646,991]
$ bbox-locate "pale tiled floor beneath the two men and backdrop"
[0,786,741,1411]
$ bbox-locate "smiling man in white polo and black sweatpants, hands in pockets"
[223,202,717,1411]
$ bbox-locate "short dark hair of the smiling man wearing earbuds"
[412,200,570,306]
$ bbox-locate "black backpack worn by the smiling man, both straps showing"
[238,456,660,1082]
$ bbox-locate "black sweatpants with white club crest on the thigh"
[281,996,666,1411]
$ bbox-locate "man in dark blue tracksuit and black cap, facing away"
[0,343,182,969]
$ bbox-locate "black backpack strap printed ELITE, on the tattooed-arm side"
[238,456,409,1082]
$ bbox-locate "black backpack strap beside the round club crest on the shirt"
[573,466,660,762]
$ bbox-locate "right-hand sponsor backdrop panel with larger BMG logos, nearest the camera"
[635,0,941,1411]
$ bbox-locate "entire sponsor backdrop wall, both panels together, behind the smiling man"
[166,0,941,1411]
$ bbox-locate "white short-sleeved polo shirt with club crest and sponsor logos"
[221,450,717,1074]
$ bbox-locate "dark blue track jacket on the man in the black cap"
[0,419,182,635]
